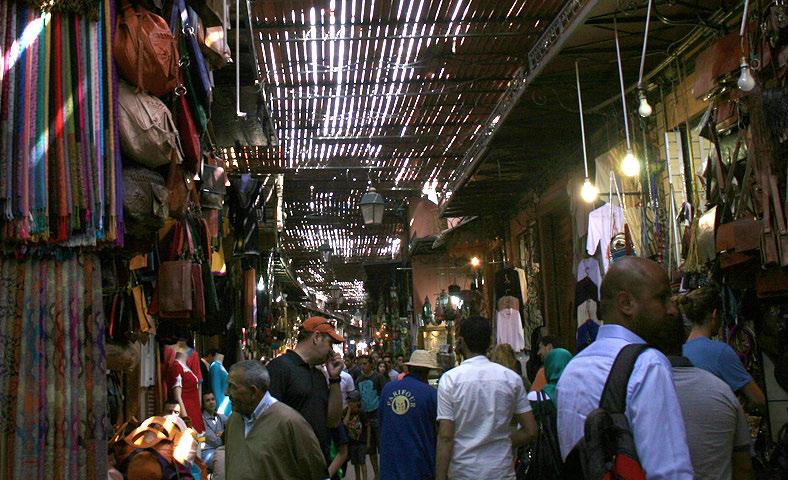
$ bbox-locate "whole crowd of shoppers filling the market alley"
[117,257,776,480]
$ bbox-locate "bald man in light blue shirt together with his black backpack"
[557,257,693,480]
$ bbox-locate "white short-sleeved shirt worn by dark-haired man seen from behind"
[438,355,531,480]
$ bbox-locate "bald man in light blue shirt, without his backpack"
[557,257,693,480]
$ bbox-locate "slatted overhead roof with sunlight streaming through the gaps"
[240,0,561,295]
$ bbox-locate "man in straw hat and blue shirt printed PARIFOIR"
[379,350,438,480]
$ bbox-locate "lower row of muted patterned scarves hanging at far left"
[0,253,108,480]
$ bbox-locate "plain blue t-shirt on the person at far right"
[682,337,752,392]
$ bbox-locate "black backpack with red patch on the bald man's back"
[565,344,649,480]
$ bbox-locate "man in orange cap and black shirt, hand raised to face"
[268,317,345,462]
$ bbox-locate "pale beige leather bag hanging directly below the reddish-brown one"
[118,82,183,168]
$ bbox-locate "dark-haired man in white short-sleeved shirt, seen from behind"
[436,317,536,480]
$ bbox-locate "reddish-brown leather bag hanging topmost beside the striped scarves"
[112,0,178,97]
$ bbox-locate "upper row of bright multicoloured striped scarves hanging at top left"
[0,0,123,247]
